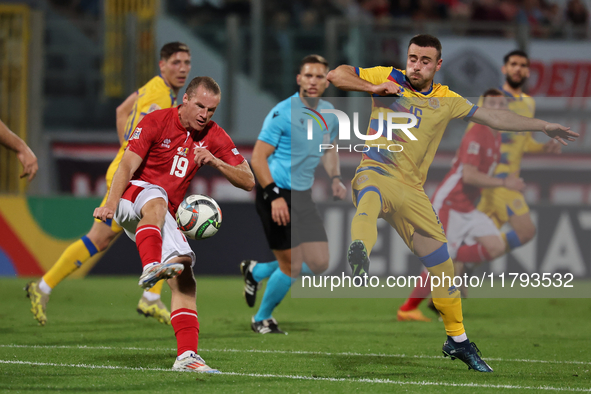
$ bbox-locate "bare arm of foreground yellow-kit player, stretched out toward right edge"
[472,107,579,145]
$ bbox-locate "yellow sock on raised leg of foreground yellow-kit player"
[351,191,382,256]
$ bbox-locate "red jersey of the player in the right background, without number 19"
[432,124,501,213]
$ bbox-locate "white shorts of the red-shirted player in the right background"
[443,209,501,259]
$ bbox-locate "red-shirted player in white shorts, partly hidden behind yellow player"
[397,89,525,321]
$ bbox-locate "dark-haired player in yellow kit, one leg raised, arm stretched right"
[328,35,578,372]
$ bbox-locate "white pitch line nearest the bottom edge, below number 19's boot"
[0,360,591,392]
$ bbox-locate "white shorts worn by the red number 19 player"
[114,181,195,266]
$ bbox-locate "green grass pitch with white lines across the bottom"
[0,277,591,393]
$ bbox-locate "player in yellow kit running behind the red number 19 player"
[25,42,191,325]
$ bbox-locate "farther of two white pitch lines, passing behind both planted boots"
[0,344,591,365]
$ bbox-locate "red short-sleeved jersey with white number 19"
[127,106,244,216]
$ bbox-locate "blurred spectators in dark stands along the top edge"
[51,0,589,37]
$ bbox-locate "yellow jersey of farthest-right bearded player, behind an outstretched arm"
[466,89,544,178]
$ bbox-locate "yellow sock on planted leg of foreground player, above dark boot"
[427,258,466,336]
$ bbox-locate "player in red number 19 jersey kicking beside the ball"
[94,77,254,373]
